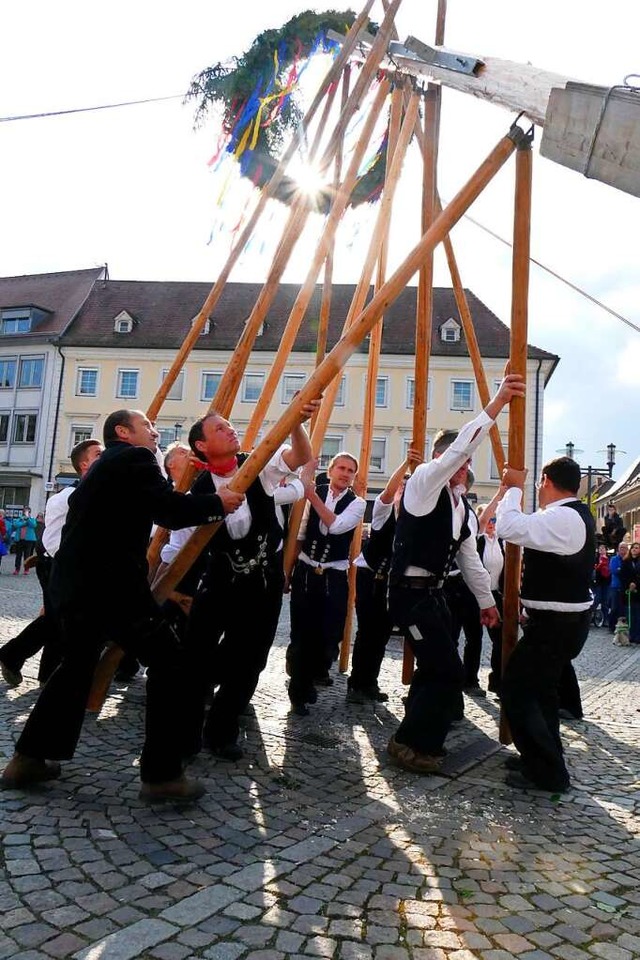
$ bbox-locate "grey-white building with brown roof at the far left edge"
[0,267,105,514]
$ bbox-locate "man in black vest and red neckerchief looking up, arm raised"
[185,400,320,760]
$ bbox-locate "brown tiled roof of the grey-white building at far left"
[0,267,104,343]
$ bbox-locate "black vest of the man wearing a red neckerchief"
[191,453,282,573]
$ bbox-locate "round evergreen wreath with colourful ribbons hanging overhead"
[187,10,387,207]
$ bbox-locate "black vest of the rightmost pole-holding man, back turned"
[520,500,596,603]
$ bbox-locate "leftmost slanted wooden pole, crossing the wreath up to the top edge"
[147,0,382,421]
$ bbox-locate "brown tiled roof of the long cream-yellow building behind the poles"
[63,280,557,361]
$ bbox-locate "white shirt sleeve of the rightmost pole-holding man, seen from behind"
[496,487,587,557]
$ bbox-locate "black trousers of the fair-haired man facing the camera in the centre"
[287,560,349,703]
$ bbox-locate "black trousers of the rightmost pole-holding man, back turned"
[502,610,591,790]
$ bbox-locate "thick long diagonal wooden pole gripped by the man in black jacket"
[154,125,524,603]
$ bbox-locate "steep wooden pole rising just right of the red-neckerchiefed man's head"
[244,80,389,447]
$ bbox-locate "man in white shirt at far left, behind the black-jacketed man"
[0,440,103,687]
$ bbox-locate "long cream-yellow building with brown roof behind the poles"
[53,280,558,502]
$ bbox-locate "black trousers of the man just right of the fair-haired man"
[349,567,392,690]
